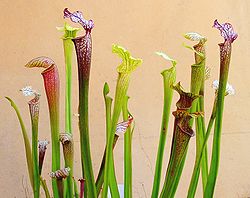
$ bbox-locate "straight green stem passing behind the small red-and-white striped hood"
[122,96,132,198]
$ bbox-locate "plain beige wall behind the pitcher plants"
[0,0,250,197]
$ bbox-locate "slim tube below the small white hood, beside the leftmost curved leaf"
[28,94,40,198]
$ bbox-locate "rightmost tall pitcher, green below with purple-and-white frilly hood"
[205,20,238,198]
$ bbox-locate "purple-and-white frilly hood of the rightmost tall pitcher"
[213,19,238,43]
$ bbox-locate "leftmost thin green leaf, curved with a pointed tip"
[5,97,34,190]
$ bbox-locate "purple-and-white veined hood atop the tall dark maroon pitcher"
[63,8,94,31]
